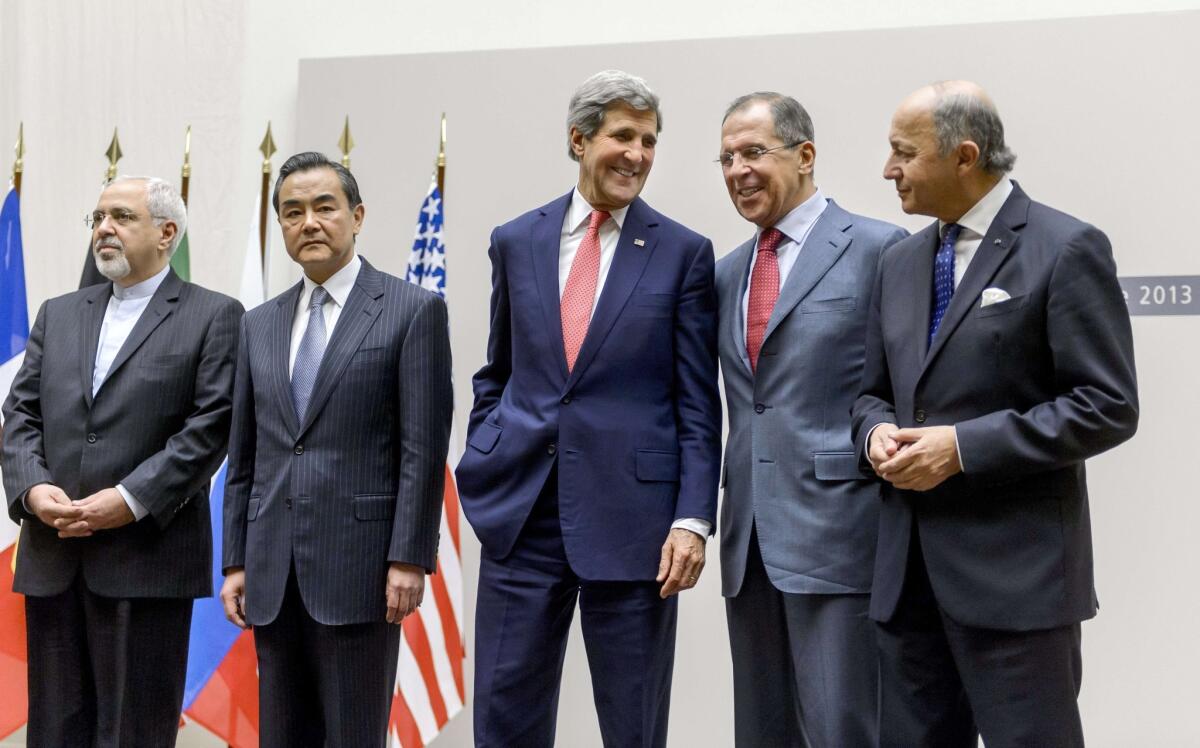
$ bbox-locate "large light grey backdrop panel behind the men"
[296,12,1200,746]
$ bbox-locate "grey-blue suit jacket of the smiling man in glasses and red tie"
[716,201,907,597]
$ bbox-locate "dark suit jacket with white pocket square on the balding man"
[853,182,1138,630]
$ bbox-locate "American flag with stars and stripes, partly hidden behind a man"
[389,180,466,748]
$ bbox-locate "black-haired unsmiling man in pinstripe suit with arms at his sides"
[221,152,452,747]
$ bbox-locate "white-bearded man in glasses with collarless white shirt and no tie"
[4,178,242,748]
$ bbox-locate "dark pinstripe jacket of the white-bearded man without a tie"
[4,271,242,598]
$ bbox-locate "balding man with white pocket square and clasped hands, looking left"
[853,82,1138,748]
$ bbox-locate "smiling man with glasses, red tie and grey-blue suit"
[716,92,907,748]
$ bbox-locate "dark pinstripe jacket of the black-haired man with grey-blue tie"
[222,259,454,626]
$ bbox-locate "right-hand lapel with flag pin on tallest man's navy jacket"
[559,198,659,387]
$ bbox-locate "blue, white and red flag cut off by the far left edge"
[0,187,29,738]
